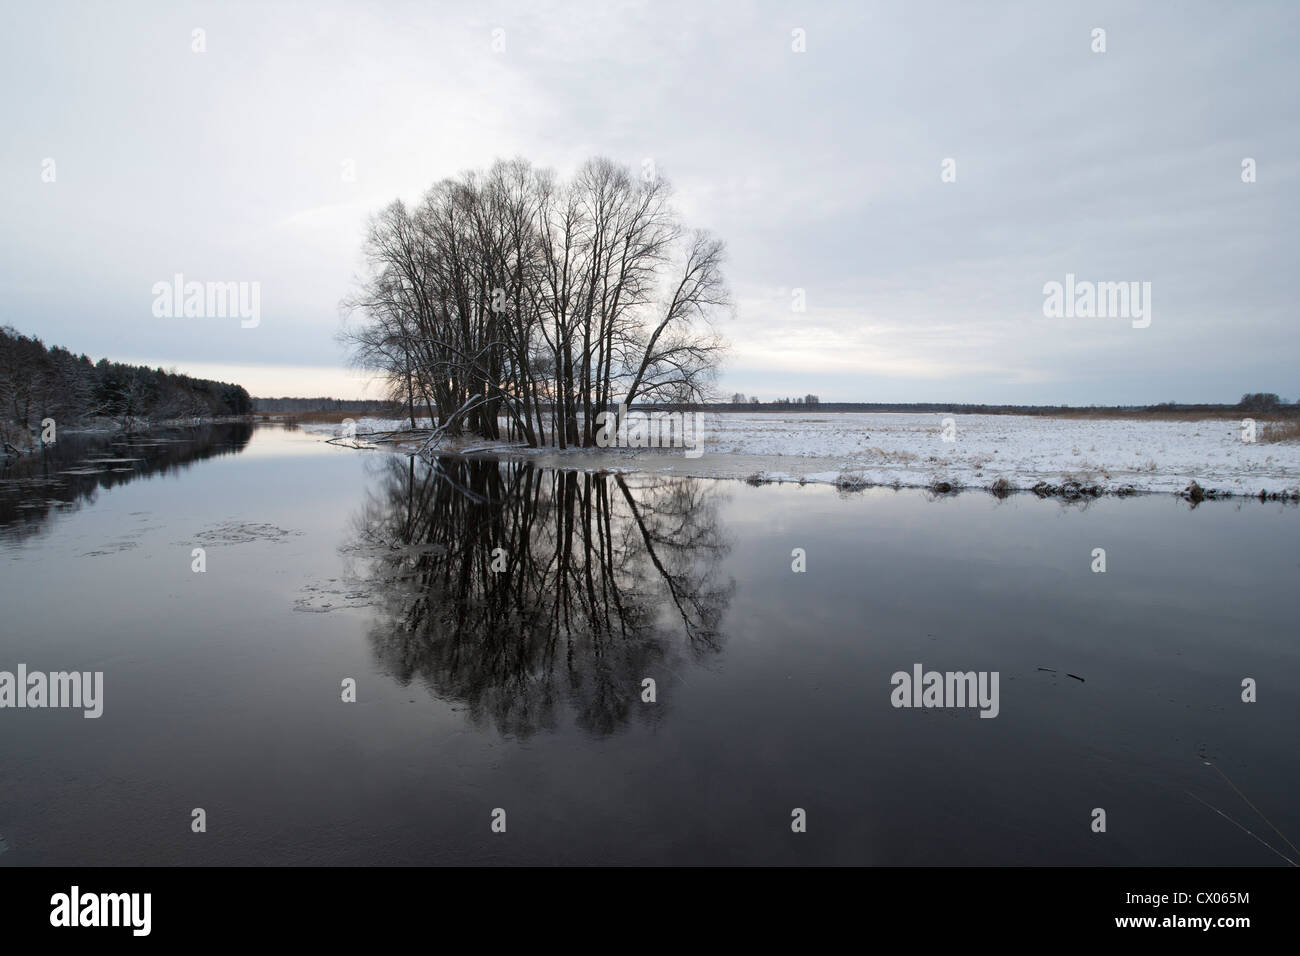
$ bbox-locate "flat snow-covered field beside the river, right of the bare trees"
[304,412,1300,496]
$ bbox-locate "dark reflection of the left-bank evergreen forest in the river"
[0,423,252,538]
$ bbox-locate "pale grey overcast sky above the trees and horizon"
[0,0,1300,405]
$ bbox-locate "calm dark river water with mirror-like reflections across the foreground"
[0,427,1300,865]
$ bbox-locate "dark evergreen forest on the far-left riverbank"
[0,326,252,447]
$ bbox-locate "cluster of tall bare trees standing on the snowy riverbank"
[345,159,728,447]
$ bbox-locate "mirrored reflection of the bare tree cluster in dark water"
[356,457,731,735]
